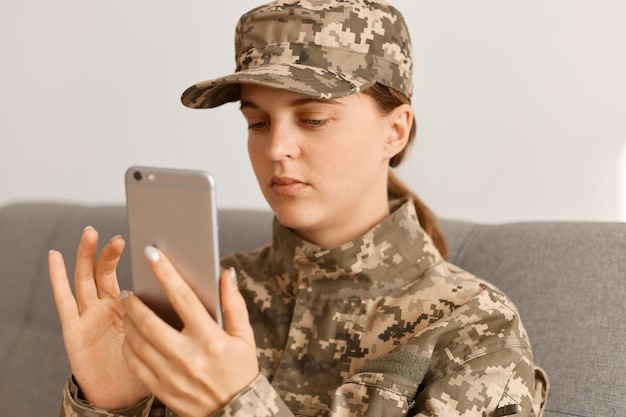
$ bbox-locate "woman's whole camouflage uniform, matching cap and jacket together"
[61,0,546,417]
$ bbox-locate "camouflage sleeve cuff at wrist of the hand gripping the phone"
[214,374,293,417]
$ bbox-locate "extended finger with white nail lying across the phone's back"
[145,246,219,332]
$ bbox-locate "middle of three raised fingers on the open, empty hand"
[74,226,98,311]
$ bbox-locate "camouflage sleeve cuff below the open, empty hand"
[59,376,154,417]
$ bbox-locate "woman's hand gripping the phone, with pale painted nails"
[120,247,259,416]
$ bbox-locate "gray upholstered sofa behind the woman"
[0,202,626,417]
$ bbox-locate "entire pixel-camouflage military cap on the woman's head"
[181,0,413,108]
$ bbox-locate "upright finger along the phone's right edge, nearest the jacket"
[220,267,254,342]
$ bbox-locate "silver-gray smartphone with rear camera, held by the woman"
[125,166,223,330]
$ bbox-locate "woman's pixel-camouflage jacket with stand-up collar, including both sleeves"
[60,201,546,417]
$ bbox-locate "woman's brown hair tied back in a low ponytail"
[363,83,448,259]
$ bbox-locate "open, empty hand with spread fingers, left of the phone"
[48,227,150,410]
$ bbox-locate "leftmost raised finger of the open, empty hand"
[48,251,78,331]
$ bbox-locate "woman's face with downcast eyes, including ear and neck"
[241,85,412,248]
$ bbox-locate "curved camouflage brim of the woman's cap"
[181,64,375,109]
